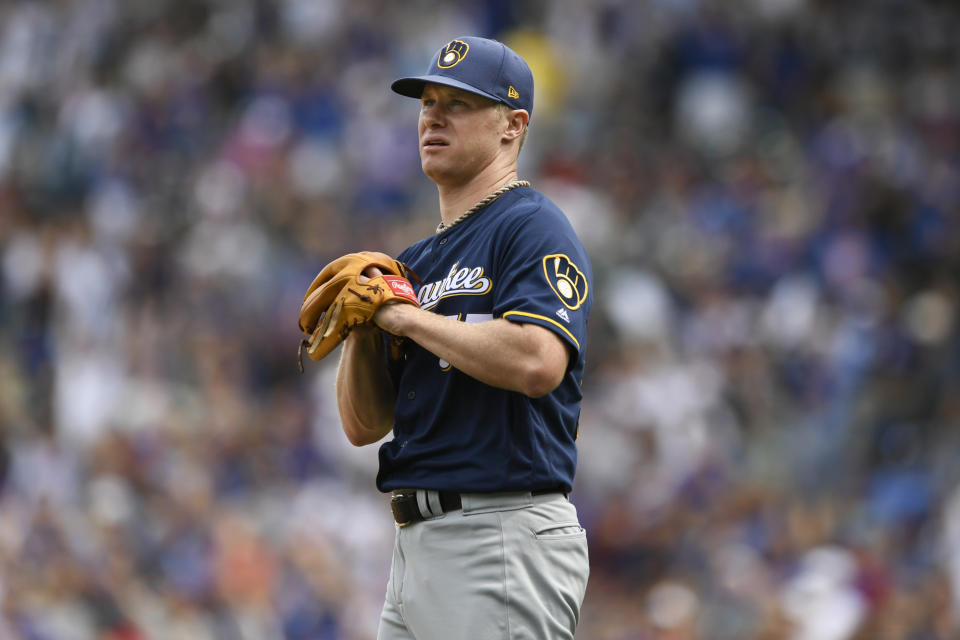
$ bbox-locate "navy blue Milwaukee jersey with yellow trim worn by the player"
[377,187,592,492]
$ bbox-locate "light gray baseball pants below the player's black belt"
[377,491,590,640]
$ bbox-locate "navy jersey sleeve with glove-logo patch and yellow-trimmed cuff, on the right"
[494,209,593,353]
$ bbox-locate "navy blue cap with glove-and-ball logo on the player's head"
[390,37,533,116]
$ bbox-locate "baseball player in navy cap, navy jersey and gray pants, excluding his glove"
[316,37,592,640]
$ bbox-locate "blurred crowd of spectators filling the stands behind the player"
[0,0,960,640]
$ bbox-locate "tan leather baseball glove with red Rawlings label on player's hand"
[297,251,420,371]
